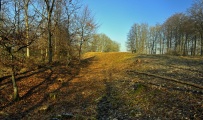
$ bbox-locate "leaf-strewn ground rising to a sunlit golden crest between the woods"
[0,52,203,120]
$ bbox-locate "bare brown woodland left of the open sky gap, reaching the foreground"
[0,0,120,100]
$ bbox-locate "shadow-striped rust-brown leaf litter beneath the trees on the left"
[0,60,88,119]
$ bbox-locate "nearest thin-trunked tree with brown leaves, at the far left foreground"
[0,1,40,100]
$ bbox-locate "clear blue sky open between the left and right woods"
[83,0,193,51]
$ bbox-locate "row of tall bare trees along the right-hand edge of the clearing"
[126,0,203,56]
